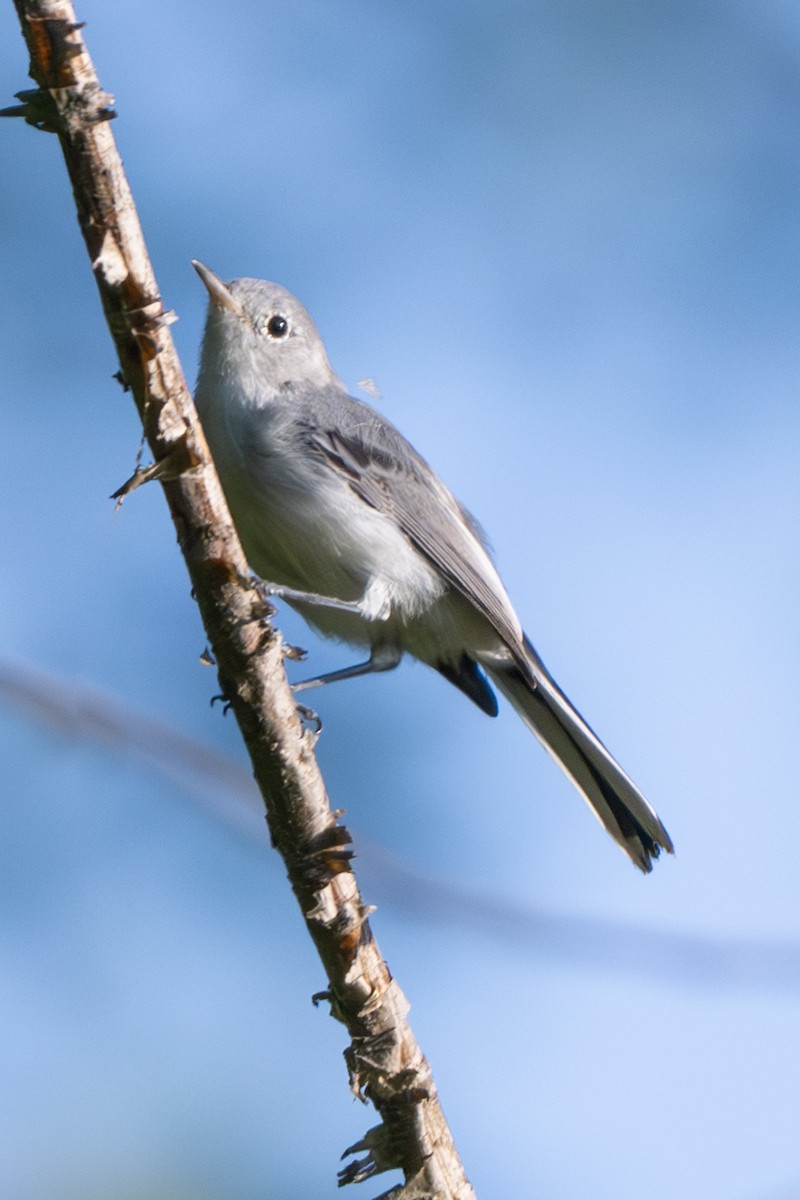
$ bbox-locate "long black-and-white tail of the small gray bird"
[485,638,673,871]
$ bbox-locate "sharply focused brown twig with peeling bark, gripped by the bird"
[4,0,474,1200]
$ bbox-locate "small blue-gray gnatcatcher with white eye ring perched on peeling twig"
[193,262,673,871]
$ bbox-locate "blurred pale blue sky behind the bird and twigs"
[0,0,800,1200]
